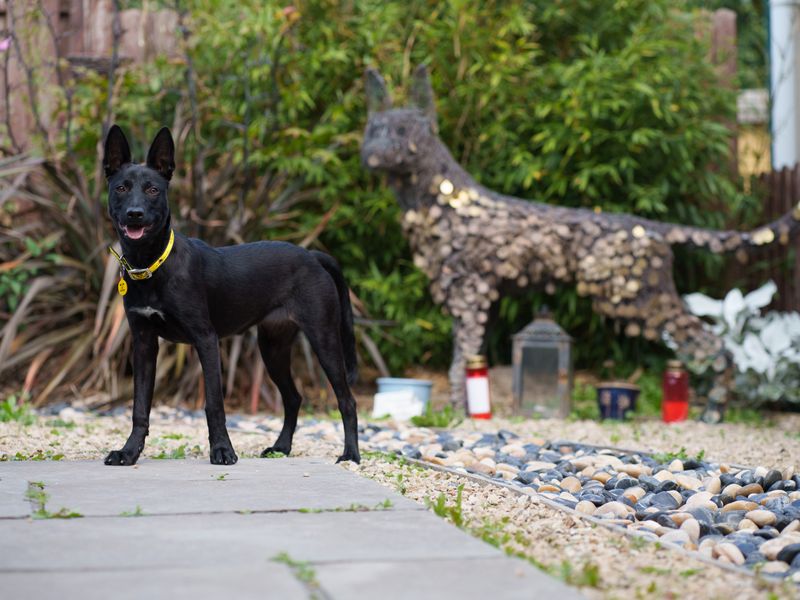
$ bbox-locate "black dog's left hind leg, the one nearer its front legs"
[258,325,303,457]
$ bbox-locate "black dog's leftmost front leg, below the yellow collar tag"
[105,325,158,465]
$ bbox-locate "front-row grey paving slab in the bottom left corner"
[0,563,308,600]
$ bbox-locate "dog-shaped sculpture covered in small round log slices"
[361,66,800,422]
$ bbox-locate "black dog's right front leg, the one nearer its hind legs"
[195,333,239,465]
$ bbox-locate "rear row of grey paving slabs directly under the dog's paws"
[0,458,421,516]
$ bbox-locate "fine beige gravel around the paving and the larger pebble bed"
[0,408,800,598]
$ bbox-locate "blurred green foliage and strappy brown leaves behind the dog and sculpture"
[0,0,766,408]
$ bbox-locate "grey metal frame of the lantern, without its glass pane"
[512,315,573,418]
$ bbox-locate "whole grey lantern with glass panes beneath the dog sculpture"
[512,311,572,418]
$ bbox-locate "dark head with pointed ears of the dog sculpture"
[361,65,438,175]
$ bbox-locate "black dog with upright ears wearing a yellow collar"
[103,125,360,465]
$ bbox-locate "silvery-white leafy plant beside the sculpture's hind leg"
[685,281,800,404]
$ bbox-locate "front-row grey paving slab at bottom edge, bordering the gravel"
[316,556,582,600]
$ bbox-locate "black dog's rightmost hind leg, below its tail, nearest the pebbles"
[303,323,361,463]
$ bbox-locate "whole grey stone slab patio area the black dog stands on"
[0,458,578,600]
